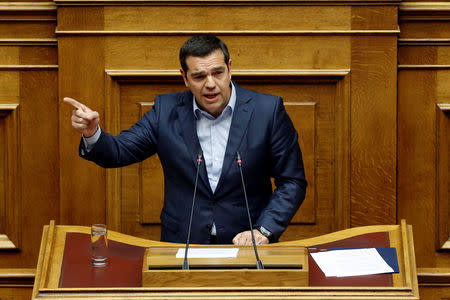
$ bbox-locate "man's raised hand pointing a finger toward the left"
[63,97,100,137]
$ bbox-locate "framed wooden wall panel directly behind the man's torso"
[106,70,350,239]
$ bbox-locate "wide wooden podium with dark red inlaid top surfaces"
[33,221,419,299]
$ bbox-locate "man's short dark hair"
[180,34,230,73]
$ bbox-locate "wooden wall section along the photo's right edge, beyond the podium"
[397,2,450,299]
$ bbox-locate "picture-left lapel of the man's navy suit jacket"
[177,92,212,193]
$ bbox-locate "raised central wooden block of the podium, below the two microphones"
[142,244,308,288]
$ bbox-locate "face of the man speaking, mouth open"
[180,50,231,117]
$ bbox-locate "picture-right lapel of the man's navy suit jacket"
[215,84,253,193]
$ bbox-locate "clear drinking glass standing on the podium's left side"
[91,224,108,267]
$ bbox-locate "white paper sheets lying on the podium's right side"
[311,248,394,277]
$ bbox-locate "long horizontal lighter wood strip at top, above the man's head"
[104,5,354,32]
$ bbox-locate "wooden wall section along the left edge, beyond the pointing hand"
[0,2,59,299]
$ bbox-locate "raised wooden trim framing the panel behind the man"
[105,69,350,230]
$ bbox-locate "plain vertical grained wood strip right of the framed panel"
[351,37,397,226]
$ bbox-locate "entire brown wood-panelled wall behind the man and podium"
[0,0,450,300]
